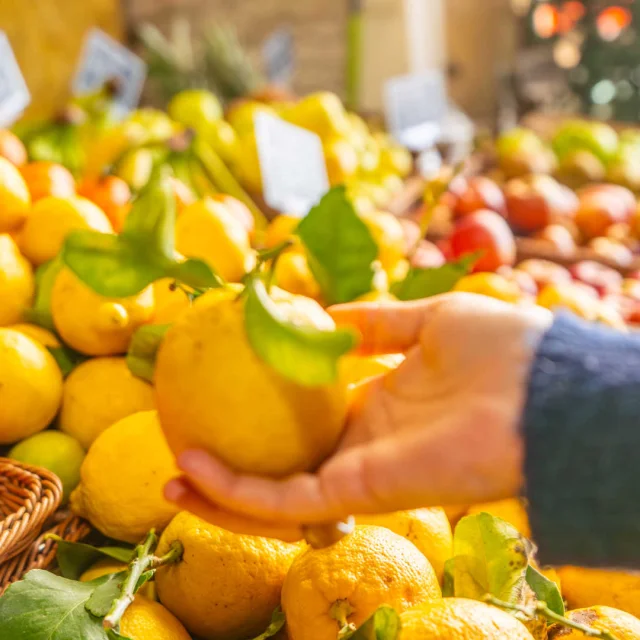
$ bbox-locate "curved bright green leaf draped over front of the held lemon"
[245,278,357,386]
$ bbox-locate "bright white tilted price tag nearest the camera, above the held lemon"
[255,113,329,217]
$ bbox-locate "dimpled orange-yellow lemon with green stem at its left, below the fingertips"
[156,512,304,640]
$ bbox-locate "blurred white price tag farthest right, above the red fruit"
[385,70,448,151]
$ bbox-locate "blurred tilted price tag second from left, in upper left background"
[73,29,147,116]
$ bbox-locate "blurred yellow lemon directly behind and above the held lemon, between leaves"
[176,198,255,282]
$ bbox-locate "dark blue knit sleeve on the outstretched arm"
[523,315,640,568]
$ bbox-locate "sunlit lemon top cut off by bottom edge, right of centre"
[398,598,536,640]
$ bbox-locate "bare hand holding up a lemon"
[165,293,552,540]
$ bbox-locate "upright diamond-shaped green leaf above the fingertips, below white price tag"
[296,187,378,304]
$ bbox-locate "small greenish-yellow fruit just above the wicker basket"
[9,431,84,504]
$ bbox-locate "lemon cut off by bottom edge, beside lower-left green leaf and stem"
[120,596,191,640]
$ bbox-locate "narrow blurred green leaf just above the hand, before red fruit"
[391,253,480,301]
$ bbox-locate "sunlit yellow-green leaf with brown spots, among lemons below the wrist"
[453,513,529,604]
